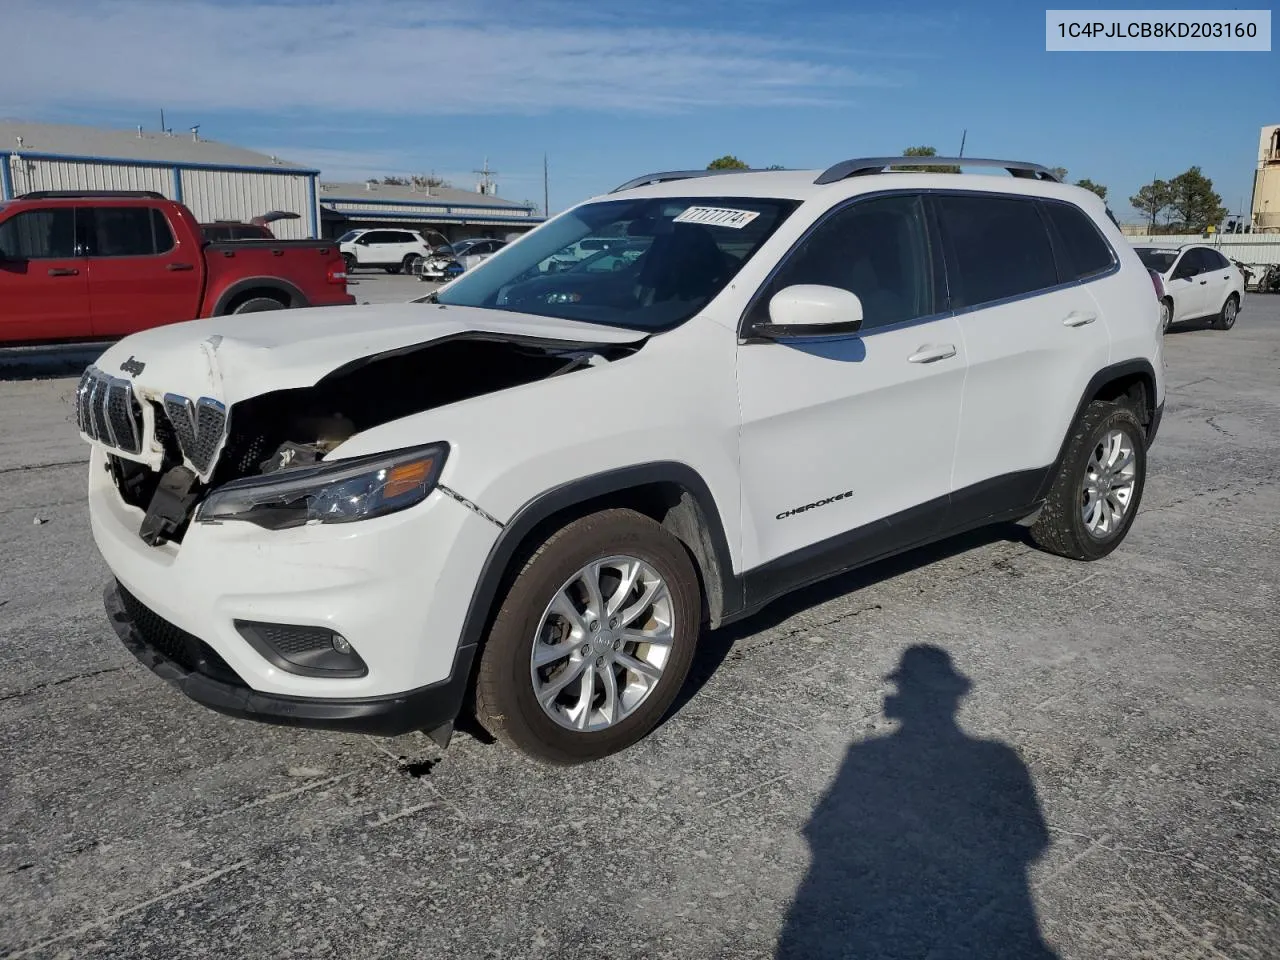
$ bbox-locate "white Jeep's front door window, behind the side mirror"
[750,195,933,330]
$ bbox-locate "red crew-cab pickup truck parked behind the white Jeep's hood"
[0,191,356,346]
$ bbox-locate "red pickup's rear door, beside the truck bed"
[79,205,204,337]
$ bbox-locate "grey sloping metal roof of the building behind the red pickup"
[0,120,311,173]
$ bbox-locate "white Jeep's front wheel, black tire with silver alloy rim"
[475,509,701,764]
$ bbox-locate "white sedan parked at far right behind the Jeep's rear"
[1134,243,1244,330]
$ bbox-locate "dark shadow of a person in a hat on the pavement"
[777,645,1056,960]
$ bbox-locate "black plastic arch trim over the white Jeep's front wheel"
[458,461,742,660]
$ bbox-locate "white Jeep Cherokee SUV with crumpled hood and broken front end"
[77,157,1164,763]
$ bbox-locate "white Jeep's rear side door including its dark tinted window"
[934,193,1115,506]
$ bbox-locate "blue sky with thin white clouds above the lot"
[0,0,1280,218]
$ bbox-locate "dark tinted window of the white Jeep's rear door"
[937,195,1059,310]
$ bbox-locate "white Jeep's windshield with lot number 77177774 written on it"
[436,197,799,330]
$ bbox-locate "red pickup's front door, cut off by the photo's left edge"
[0,206,92,343]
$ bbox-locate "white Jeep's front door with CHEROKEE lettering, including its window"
[737,193,965,576]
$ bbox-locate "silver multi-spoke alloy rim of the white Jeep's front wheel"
[529,556,676,732]
